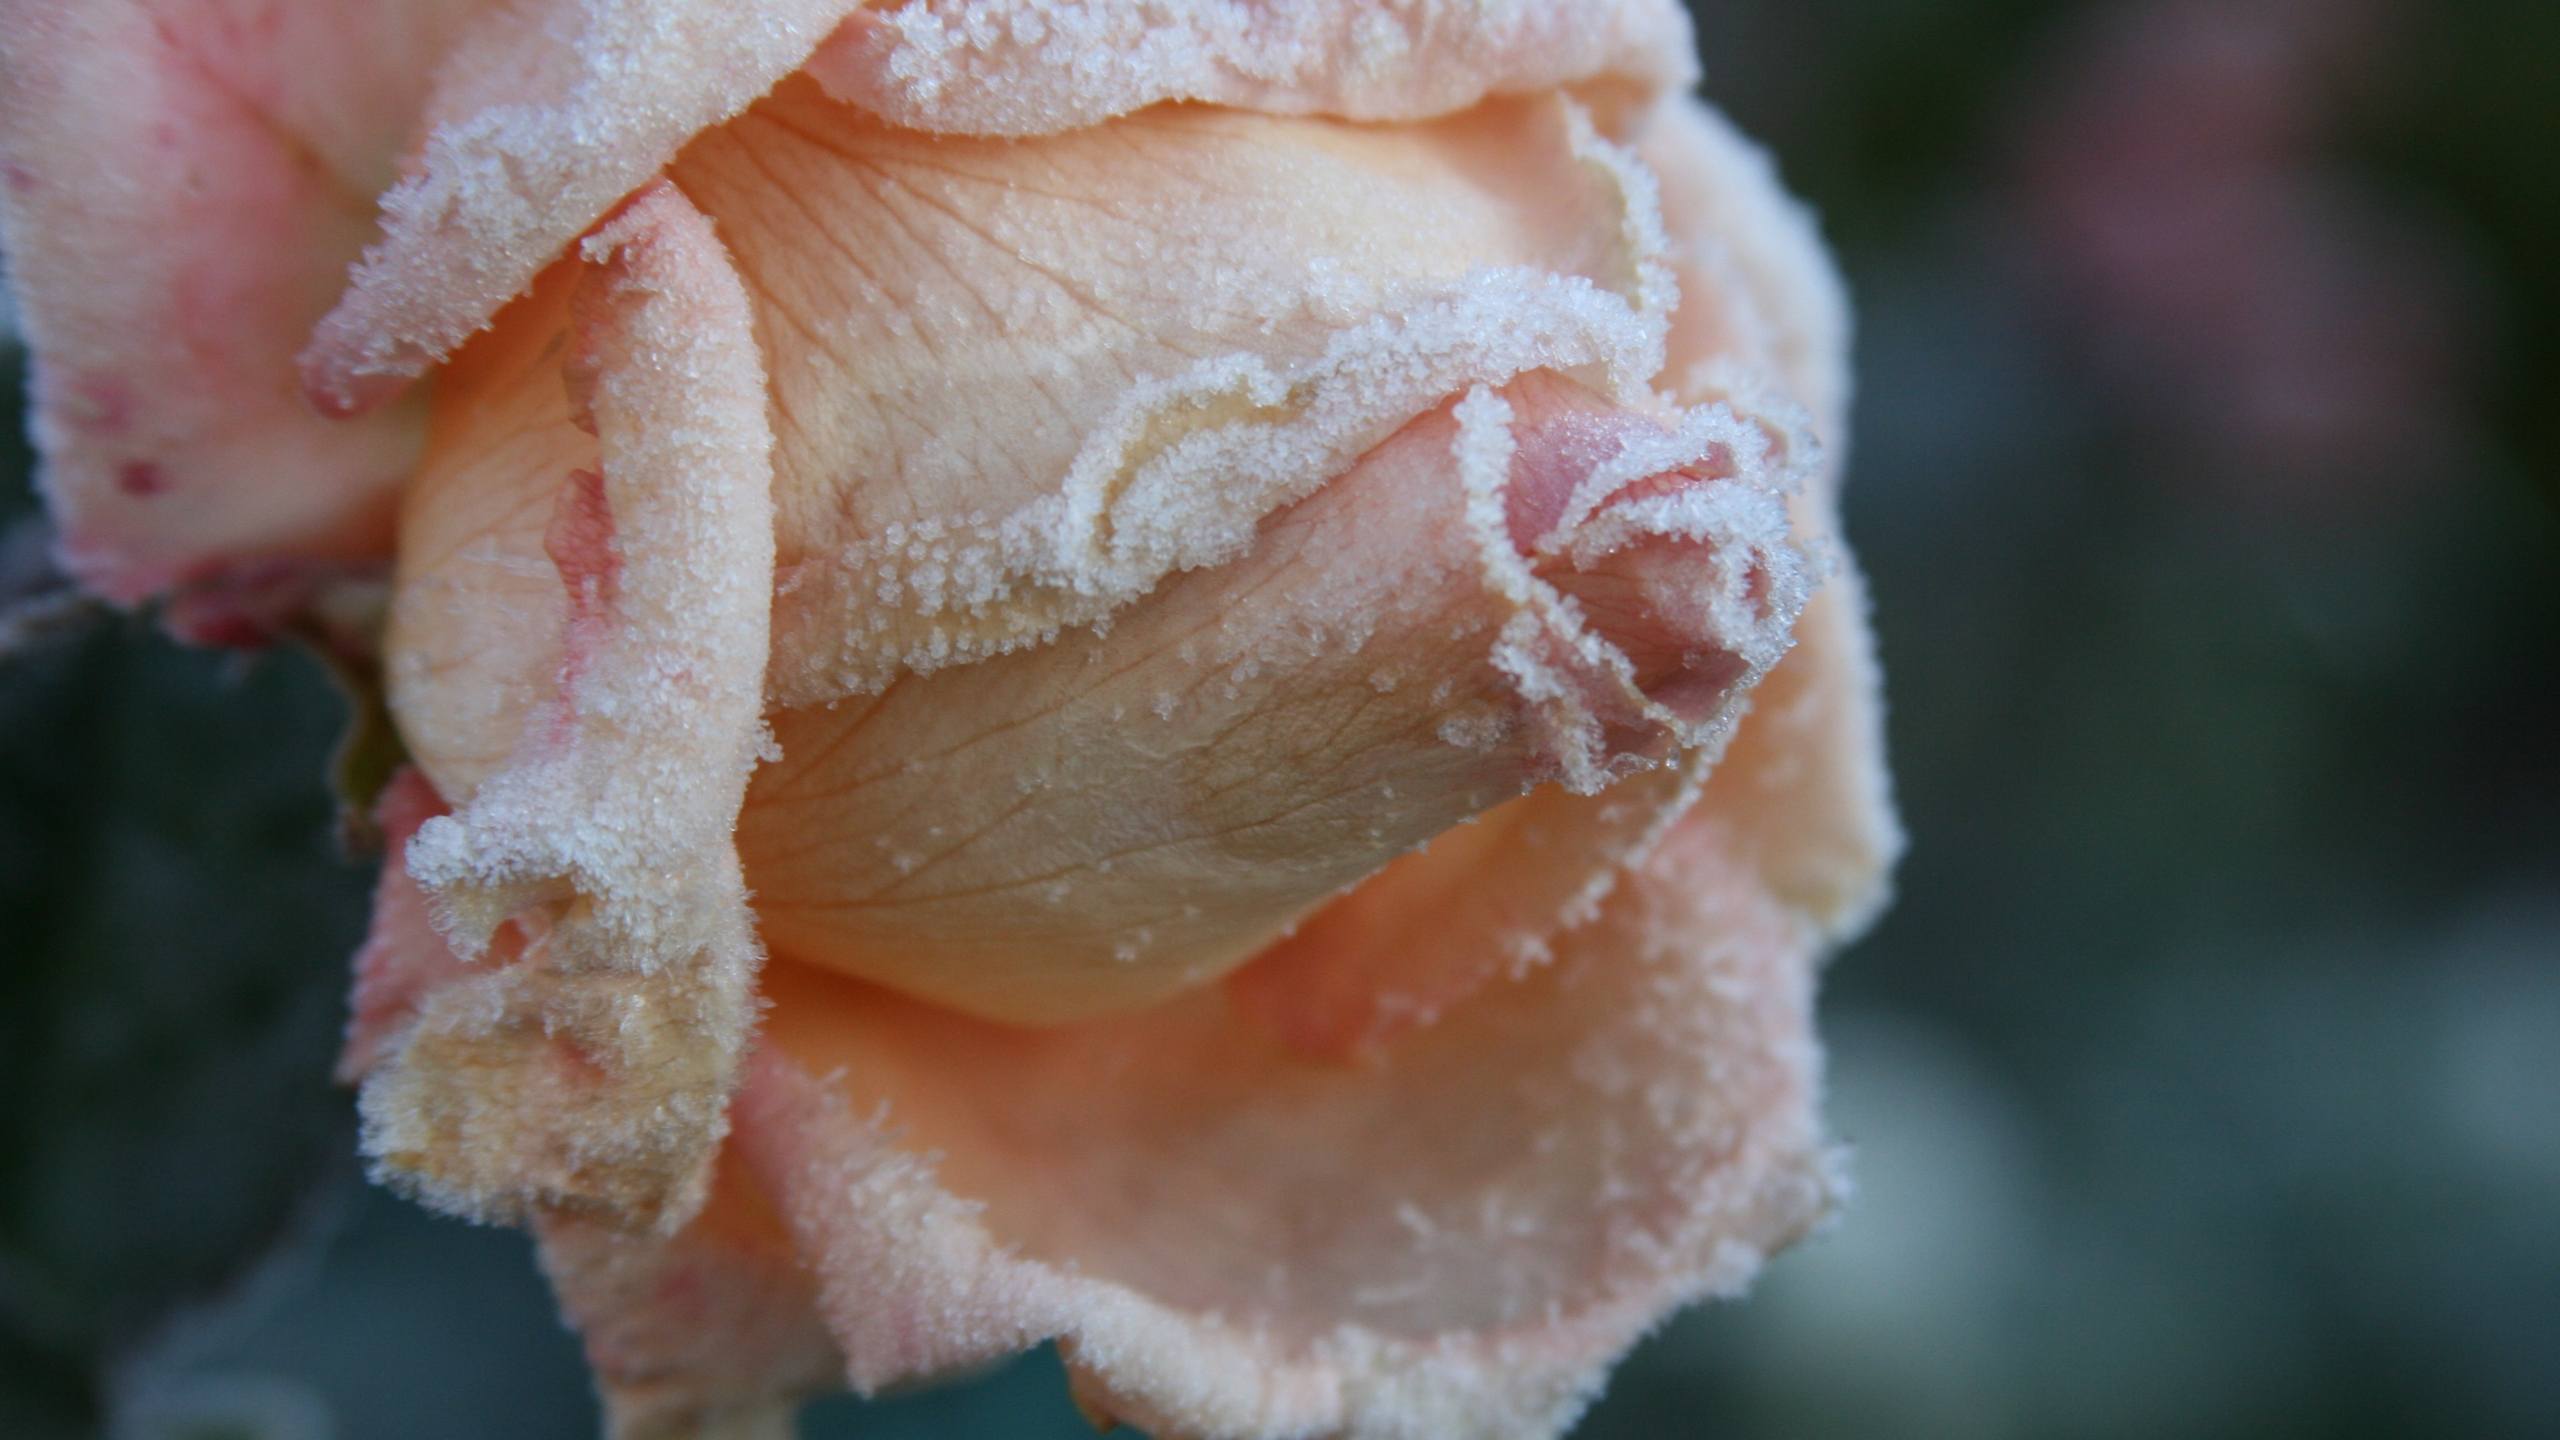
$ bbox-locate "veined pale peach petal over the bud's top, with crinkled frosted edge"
[673,85,1672,705]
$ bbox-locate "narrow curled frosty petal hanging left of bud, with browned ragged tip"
[364,184,773,1225]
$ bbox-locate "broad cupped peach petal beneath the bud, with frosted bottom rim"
[737,828,1830,1440]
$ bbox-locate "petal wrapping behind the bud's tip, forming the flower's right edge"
[1231,97,1900,1053]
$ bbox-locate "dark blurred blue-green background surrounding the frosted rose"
[0,0,2560,1440]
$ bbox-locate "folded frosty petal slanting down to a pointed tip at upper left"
[305,0,858,413]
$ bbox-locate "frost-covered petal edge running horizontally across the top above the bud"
[809,0,1697,136]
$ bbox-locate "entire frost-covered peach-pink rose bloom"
[0,0,1894,1435]
